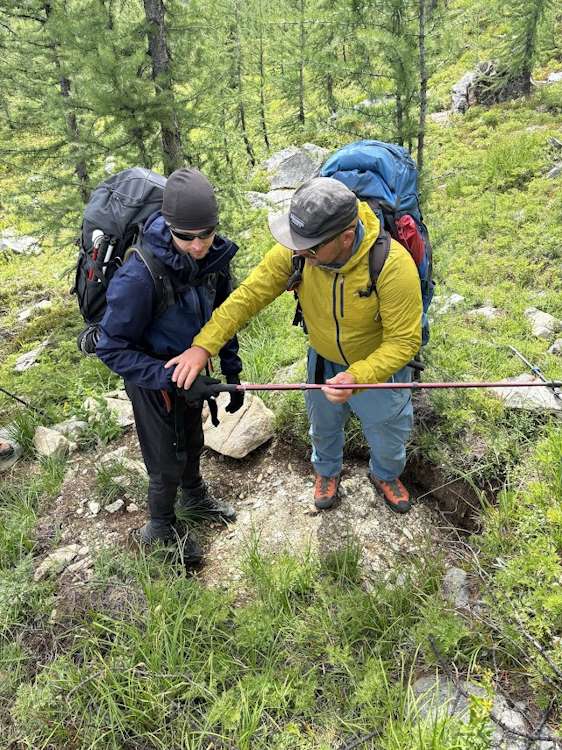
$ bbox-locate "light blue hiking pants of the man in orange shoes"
[305,348,414,481]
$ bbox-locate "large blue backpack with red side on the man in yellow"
[320,140,435,346]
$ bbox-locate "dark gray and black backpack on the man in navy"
[71,167,174,354]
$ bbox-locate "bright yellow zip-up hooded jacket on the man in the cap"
[193,203,422,383]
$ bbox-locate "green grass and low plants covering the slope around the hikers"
[0,0,562,750]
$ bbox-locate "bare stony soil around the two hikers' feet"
[31,432,468,586]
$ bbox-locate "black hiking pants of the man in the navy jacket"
[125,382,204,524]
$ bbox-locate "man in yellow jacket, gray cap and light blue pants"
[166,177,422,513]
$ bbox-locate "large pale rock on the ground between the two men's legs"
[203,393,275,458]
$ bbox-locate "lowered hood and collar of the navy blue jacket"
[140,211,238,284]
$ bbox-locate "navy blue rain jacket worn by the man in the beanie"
[96,211,242,390]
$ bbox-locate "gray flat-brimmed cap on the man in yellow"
[269,177,357,251]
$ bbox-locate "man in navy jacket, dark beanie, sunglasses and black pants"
[96,168,243,561]
